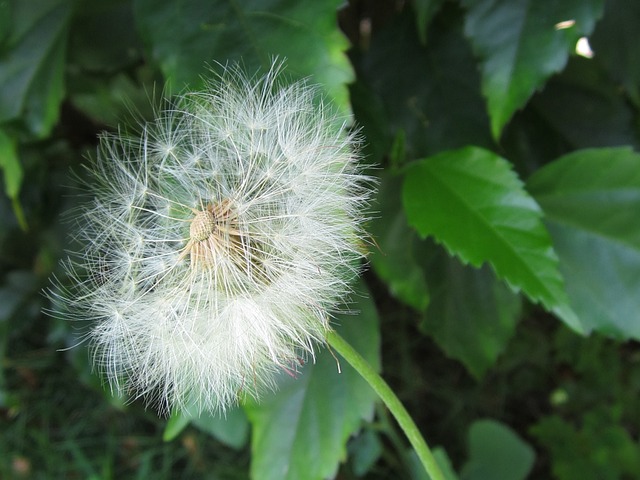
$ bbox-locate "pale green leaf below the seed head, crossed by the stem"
[245,282,380,480]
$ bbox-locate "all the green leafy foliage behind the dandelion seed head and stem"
[0,0,640,480]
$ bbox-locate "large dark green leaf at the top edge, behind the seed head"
[134,0,354,113]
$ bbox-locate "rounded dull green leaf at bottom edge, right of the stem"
[460,420,535,480]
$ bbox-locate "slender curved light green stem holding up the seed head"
[327,331,445,480]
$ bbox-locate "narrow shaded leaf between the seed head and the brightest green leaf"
[369,175,429,311]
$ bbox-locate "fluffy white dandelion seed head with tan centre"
[52,63,369,412]
